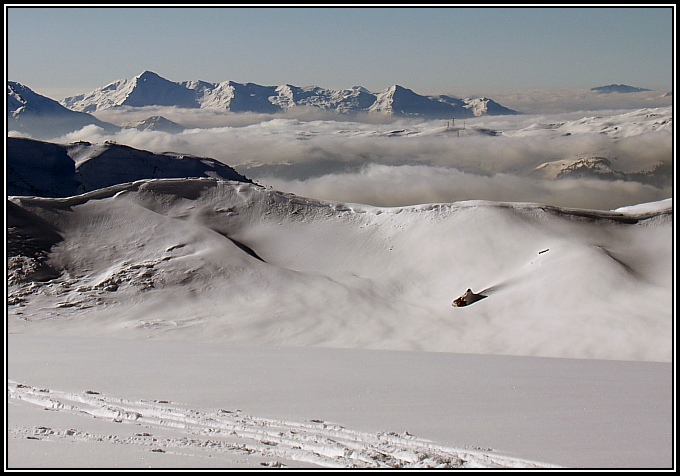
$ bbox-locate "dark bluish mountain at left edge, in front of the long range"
[7,81,119,139]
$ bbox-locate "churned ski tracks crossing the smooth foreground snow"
[8,380,556,468]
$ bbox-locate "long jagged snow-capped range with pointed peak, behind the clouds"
[61,71,518,119]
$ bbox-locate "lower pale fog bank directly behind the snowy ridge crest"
[262,164,672,210]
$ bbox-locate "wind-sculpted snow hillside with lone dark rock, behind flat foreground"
[8,179,673,361]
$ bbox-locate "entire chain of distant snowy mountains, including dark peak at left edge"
[7,71,519,139]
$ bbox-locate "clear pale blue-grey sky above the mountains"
[5,5,675,99]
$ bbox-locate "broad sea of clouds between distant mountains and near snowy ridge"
[23,108,673,209]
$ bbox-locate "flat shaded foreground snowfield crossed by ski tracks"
[6,334,674,470]
